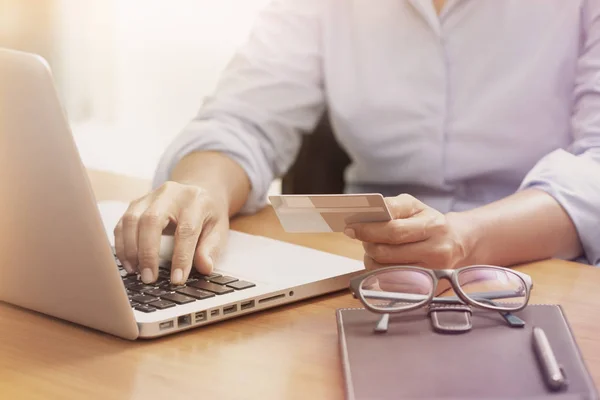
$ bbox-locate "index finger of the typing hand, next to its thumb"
[171,209,206,284]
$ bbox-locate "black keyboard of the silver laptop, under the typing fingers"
[115,256,256,313]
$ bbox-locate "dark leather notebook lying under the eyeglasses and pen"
[337,304,598,400]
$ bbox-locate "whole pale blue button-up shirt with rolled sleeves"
[154,0,600,265]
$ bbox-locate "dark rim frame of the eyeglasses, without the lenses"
[349,264,533,314]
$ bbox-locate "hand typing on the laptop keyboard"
[114,181,229,284]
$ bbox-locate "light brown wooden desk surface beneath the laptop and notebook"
[0,172,600,400]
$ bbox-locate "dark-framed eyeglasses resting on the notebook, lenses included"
[350,265,533,332]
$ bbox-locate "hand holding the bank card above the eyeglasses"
[344,194,476,269]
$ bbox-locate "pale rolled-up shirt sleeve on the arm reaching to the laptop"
[153,0,324,213]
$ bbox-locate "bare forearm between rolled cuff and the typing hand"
[170,151,250,216]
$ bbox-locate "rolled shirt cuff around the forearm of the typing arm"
[152,120,273,214]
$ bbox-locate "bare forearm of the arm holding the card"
[448,189,582,266]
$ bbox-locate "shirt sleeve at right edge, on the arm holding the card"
[520,0,600,266]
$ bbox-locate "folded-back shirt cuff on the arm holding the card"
[519,149,600,266]
